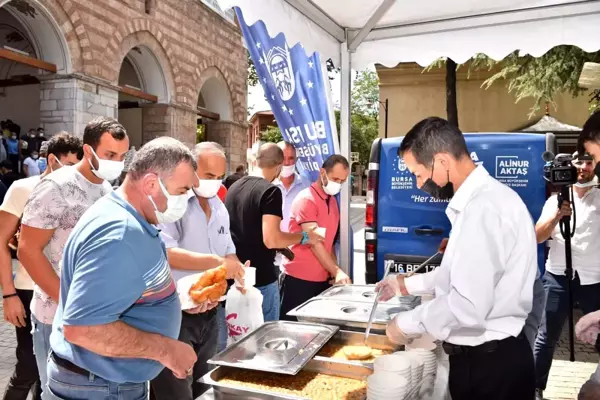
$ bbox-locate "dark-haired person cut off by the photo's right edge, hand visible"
[575,112,600,400]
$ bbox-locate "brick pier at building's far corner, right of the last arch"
[206,121,248,171]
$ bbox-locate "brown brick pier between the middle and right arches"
[142,104,198,148]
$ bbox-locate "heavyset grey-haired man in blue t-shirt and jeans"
[48,137,197,400]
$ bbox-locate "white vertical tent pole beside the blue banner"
[338,42,352,278]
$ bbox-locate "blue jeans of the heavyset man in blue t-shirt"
[48,358,148,400]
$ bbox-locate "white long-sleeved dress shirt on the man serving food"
[396,166,537,346]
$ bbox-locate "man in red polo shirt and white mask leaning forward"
[280,155,351,321]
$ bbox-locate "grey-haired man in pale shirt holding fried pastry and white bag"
[151,142,244,400]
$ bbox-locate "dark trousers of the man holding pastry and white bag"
[150,308,219,400]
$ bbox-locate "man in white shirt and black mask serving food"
[378,118,537,400]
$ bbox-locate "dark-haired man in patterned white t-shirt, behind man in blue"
[18,117,129,400]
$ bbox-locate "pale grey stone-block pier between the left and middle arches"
[40,75,119,137]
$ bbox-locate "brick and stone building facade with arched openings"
[0,0,247,162]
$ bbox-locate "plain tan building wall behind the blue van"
[377,64,589,137]
